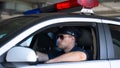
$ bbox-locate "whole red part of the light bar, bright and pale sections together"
[55,0,99,10]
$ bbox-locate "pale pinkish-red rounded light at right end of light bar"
[77,0,99,8]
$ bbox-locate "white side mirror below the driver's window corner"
[6,47,37,62]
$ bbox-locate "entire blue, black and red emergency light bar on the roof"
[23,0,99,15]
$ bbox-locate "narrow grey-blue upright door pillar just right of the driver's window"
[97,23,107,60]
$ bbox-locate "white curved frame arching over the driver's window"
[0,17,101,55]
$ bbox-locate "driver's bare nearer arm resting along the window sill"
[46,51,87,63]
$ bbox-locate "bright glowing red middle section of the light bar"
[56,0,80,10]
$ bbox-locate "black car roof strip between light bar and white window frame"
[28,13,120,21]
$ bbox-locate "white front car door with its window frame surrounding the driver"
[0,14,110,68]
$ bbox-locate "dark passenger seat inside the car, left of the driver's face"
[30,32,55,53]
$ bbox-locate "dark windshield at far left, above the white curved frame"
[0,17,36,39]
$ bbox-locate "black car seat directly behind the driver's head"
[77,28,93,60]
